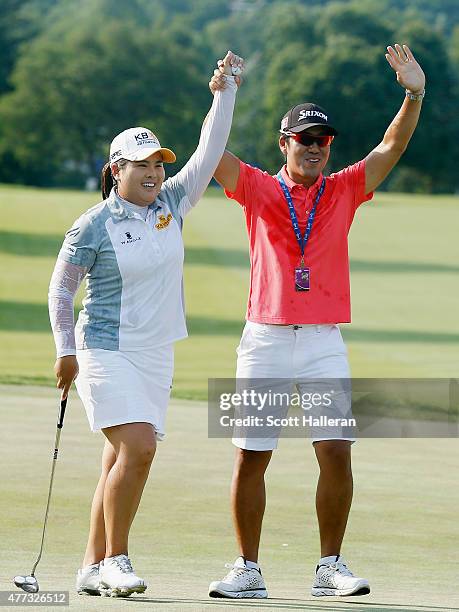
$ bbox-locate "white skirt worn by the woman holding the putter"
[75,344,174,440]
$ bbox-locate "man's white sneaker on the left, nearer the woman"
[209,557,268,599]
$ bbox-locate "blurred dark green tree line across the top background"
[0,0,459,193]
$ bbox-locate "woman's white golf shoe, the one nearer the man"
[99,555,147,597]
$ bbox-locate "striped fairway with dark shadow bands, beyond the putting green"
[0,186,459,399]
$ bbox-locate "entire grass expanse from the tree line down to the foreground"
[0,187,459,612]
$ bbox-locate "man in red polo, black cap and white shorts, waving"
[209,45,425,598]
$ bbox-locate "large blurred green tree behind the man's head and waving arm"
[208,1,459,191]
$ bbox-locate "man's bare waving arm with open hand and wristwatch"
[365,44,425,193]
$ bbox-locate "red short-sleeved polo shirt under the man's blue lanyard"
[225,161,373,325]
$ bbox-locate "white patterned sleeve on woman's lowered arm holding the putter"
[48,259,88,358]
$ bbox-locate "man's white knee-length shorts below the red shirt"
[233,321,355,451]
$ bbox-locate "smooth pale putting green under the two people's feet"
[0,386,459,612]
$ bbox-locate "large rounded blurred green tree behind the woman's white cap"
[0,0,211,184]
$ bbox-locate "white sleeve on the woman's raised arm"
[169,76,237,217]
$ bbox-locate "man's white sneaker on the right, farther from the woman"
[311,555,370,597]
